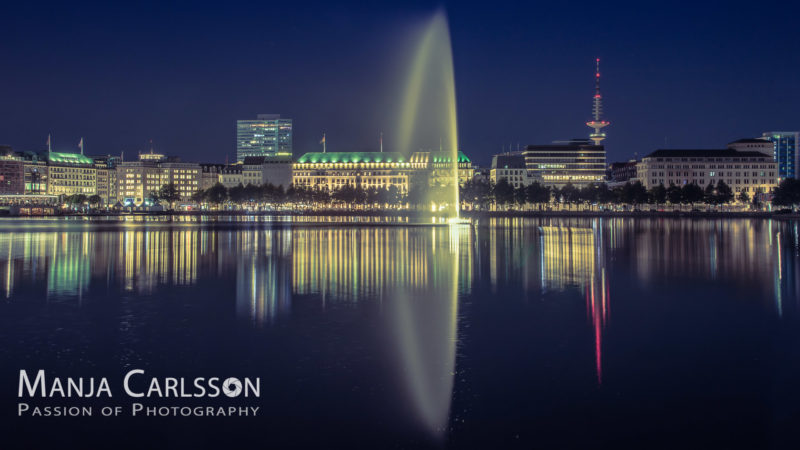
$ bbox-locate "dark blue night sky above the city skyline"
[0,1,800,164]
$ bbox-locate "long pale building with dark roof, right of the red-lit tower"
[636,148,778,194]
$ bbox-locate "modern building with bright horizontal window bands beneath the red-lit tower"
[522,139,606,187]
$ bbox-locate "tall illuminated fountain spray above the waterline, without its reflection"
[397,10,459,218]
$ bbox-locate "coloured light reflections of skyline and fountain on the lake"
[0,218,799,442]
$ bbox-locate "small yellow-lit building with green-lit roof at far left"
[47,152,97,197]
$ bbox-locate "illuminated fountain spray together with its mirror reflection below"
[387,11,471,440]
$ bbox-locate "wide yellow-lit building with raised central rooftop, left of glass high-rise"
[117,152,201,206]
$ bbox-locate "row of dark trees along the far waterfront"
[53,179,800,212]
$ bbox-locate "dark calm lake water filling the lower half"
[0,218,800,448]
